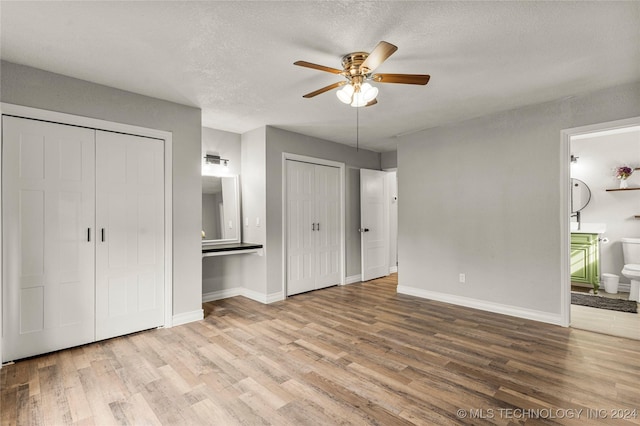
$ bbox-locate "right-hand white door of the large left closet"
[96,131,164,340]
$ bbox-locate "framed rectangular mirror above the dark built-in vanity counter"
[202,176,241,246]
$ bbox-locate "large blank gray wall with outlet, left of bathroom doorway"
[398,83,640,314]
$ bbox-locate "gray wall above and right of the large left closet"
[0,61,202,315]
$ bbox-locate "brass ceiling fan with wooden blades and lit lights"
[293,41,430,107]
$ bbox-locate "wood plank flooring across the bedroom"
[0,276,640,426]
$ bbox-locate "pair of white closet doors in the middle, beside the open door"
[286,160,341,296]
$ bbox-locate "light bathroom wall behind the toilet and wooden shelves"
[571,128,640,290]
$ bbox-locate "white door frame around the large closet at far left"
[0,103,173,362]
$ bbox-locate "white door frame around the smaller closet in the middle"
[282,152,347,300]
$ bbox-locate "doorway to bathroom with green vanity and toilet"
[562,117,640,340]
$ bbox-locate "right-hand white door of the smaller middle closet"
[314,165,340,288]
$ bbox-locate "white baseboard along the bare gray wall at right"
[397,285,562,325]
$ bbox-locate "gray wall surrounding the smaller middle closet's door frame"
[264,126,380,294]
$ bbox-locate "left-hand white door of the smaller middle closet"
[286,160,316,296]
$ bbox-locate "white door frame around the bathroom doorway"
[560,117,640,327]
